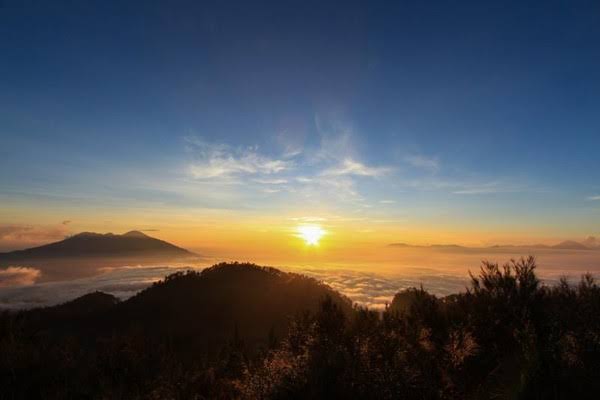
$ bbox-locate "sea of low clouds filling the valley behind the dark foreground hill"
[0,255,600,309]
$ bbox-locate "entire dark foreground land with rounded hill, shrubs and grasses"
[0,258,600,399]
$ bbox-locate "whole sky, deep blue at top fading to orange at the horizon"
[0,0,600,261]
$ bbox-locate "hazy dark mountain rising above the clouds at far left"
[0,231,194,263]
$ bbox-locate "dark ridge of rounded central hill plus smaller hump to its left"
[8,263,352,356]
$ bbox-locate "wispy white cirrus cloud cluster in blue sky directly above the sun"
[185,132,392,211]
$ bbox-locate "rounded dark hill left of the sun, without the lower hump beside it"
[106,263,351,353]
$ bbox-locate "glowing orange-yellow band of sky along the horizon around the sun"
[0,199,596,268]
